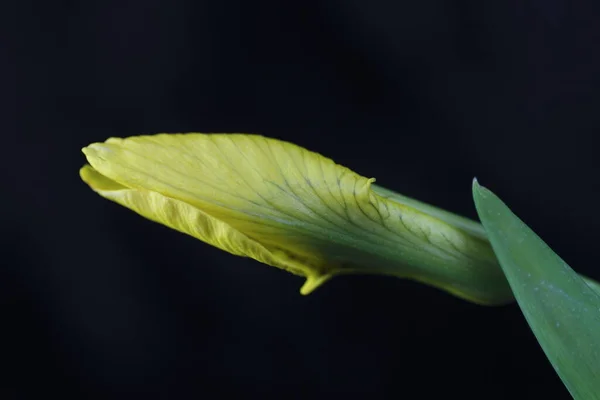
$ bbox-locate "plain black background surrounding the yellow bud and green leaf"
[8,0,600,399]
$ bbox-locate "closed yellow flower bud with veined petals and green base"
[81,133,513,304]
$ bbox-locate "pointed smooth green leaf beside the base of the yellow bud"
[473,180,600,400]
